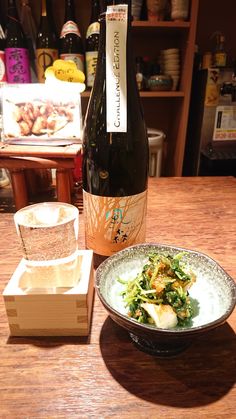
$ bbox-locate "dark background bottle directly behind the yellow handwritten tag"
[60,0,84,72]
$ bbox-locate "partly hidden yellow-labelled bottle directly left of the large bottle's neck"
[85,0,100,88]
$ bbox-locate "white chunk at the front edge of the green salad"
[141,303,178,329]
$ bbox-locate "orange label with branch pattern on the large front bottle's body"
[83,191,147,256]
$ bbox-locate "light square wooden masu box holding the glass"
[3,250,94,336]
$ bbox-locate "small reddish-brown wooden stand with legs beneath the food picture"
[0,142,81,210]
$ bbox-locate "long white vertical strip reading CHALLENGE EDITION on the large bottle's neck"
[106,4,128,132]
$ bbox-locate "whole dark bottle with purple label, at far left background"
[5,0,31,83]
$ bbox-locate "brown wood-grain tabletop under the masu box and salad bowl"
[0,177,236,419]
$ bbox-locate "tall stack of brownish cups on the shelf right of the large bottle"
[161,48,180,90]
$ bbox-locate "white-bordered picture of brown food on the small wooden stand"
[1,82,82,145]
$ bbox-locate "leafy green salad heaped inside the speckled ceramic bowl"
[118,252,196,329]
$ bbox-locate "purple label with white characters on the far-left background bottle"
[5,48,31,83]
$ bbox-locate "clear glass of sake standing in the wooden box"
[14,202,79,288]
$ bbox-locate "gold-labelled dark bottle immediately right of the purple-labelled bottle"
[36,0,58,83]
